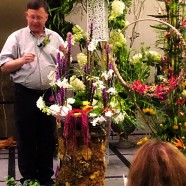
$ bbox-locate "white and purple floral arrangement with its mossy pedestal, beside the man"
[37,0,134,185]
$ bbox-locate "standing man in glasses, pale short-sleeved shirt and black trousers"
[0,0,64,185]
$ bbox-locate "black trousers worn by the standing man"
[14,84,56,184]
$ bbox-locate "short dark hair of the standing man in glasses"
[27,0,48,13]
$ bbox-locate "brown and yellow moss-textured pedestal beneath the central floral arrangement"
[56,115,110,186]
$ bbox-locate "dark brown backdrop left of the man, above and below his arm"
[0,0,27,139]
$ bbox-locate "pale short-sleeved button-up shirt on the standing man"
[0,27,64,90]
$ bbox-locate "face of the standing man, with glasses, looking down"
[25,8,48,35]
